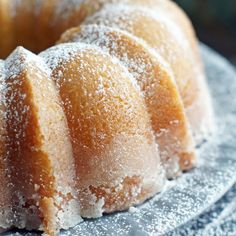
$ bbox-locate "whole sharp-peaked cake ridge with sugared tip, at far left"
[5,48,79,231]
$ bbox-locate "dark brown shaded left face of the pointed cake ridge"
[6,66,54,230]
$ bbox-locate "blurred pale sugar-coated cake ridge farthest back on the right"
[84,3,214,144]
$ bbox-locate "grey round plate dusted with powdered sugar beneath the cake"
[4,46,236,235]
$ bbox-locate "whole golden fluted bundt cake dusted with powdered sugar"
[0,0,214,235]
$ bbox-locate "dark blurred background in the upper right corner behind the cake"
[175,0,236,64]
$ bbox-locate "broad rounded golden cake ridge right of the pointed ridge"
[41,44,165,217]
